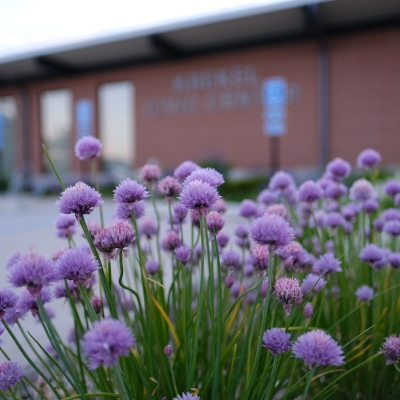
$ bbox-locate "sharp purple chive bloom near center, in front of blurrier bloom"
[180,180,221,214]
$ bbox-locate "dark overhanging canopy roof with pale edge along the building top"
[0,0,400,86]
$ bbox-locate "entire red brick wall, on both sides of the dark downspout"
[0,28,400,171]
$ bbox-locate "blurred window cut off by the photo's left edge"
[0,96,17,180]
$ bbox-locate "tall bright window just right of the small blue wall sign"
[98,81,135,170]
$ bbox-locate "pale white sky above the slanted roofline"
[0,0,283,58]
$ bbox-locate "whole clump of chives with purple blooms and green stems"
[0,145,400,400]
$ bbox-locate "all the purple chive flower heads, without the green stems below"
[6,144,400,400]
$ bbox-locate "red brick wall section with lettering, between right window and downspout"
[134,43,317,167]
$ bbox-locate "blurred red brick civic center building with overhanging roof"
[0,0,400,188]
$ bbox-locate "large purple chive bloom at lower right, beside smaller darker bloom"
[292,330,344,368]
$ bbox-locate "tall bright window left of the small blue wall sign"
[40,89,72,172]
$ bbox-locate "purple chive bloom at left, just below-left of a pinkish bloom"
[56,247,99,286]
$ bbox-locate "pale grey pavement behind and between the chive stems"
[0,195,241,366]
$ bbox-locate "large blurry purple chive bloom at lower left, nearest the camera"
[83,318,134,370]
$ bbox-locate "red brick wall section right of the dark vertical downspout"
[329,28,400,164]
